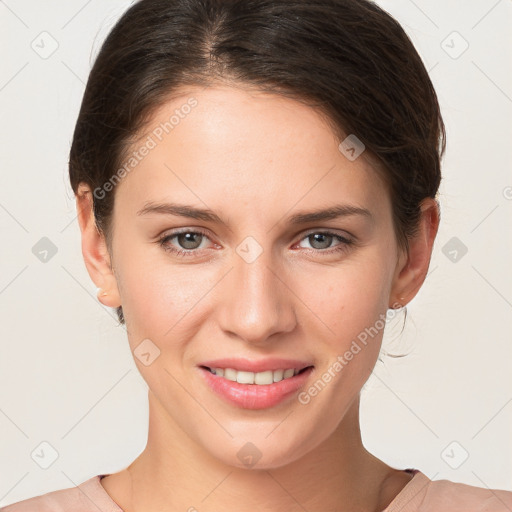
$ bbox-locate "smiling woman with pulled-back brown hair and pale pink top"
[3,0,512,512]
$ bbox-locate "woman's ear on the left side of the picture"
[76,183,121,308]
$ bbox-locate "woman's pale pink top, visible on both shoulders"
[0,469,512,512]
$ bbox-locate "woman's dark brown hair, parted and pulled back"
[69,0,446,323]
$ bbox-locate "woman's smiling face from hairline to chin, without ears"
[101,86,399,467]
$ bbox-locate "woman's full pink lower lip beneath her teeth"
[199,366,313,409]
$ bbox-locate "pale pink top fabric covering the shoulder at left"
[0,475,122,512]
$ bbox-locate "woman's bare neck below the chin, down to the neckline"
[108,391,397,512]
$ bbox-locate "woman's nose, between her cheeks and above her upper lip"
[218,244,297,344]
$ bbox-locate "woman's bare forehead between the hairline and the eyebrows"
[116,82,385,220]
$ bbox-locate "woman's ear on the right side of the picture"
[389,197,440,308]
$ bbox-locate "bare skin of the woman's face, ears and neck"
[77,85,439,512]
